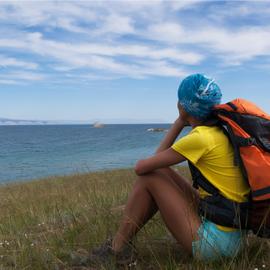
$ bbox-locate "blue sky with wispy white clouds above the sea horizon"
[0,0,270,123]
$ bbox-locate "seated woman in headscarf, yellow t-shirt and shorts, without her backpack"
[73,74,249,264]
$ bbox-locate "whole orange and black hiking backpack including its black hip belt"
[189,99,270,238]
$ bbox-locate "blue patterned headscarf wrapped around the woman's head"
[178,74,222,120]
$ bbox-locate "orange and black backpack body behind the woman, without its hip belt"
[214,99,270,237]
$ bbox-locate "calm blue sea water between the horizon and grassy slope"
[0,124,190,182]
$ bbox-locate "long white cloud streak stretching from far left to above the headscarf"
[0,33,195,77]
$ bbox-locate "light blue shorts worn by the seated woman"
[192,219,245,261]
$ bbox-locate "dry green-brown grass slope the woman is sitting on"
[0,168,270,270]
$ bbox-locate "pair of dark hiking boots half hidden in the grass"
[71,239,137,268]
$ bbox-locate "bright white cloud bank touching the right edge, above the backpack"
[139,21,270,65]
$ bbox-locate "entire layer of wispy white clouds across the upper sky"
[0,0,270,82]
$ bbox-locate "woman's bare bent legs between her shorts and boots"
[113,168,200,253]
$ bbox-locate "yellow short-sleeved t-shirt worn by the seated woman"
[172,126,250,229]
